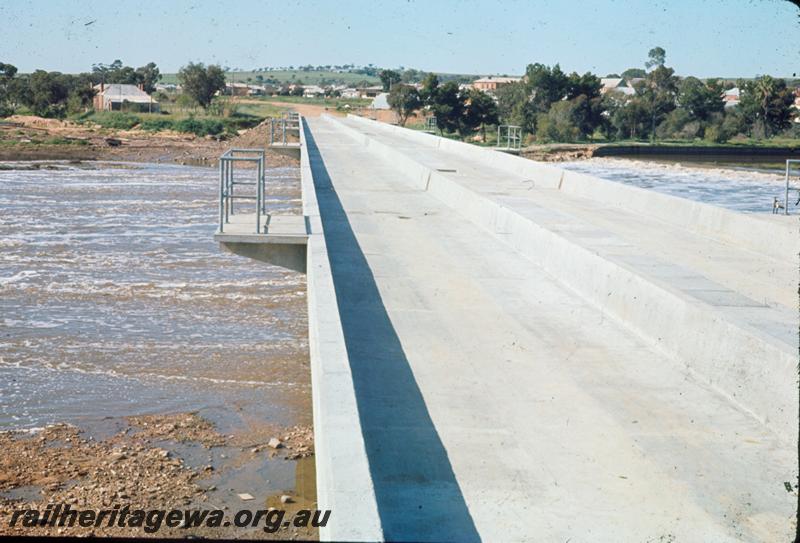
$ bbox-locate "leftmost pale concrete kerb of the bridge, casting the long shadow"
[300,119,383,541]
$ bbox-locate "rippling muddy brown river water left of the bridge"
[0,159,310,431]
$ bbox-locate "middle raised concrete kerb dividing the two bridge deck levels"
[328,117,798,442]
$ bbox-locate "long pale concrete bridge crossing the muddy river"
[217,113,800,542]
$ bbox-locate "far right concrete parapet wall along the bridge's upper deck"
[348,115,800,258]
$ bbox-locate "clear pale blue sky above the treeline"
[0,0,800,77]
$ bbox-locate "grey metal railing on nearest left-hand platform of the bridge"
[219,149,266,234]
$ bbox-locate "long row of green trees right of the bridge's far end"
[380,47,797,143]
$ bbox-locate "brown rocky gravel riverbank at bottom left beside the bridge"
[0,413,317,539]
